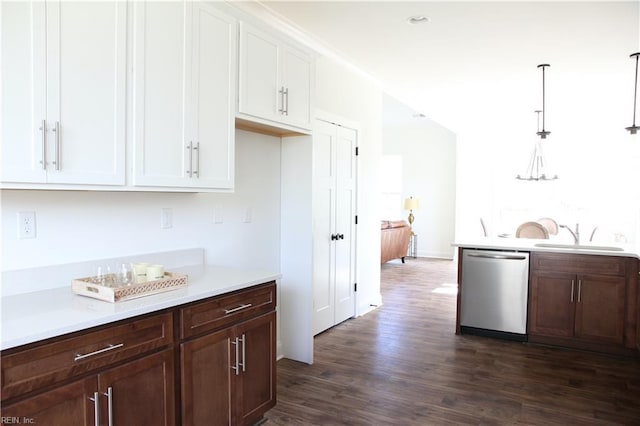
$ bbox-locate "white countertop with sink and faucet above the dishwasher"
[452,236,640,259]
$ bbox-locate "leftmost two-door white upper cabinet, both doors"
[0,1,127,185]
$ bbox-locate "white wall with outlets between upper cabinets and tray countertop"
[1,130,280,271]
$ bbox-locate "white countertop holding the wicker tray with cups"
[0,265,280,350]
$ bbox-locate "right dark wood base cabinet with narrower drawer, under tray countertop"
[180,285,276,426]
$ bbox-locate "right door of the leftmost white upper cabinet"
[46,1,127,185]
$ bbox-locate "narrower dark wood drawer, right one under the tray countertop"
[180,281,276,339]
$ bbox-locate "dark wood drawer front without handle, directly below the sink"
[531,253,626,276]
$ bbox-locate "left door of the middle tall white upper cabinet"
[133,1,192,186]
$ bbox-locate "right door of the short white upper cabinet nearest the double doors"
[282,48,312,129]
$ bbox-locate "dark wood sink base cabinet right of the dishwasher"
[528,253,637,354]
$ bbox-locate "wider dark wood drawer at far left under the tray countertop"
[1,312,173,401]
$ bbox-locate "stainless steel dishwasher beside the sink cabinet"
[460,249,529,341]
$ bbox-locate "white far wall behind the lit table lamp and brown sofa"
[383,96,456,259]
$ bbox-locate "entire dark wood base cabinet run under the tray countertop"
[0,282,276,426]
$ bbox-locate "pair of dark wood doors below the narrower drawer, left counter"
[181,313,276,426]
